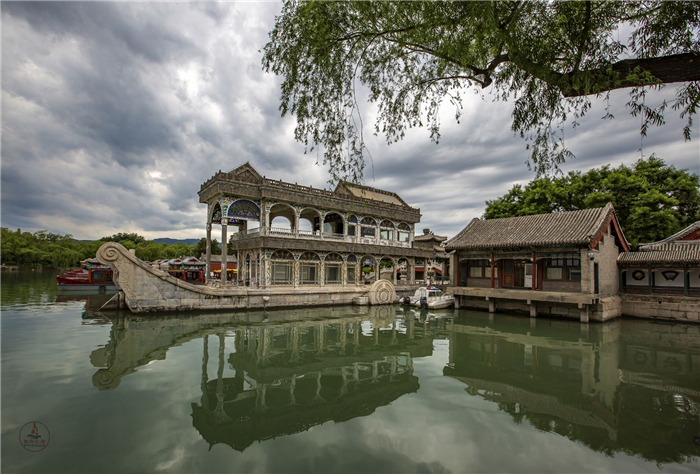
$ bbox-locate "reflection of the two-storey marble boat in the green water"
[91,306,448,451]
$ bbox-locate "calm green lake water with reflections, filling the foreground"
[2,272,700,473]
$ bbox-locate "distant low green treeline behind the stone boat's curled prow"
[0,227,202,268]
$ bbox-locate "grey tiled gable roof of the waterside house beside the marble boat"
[446,203,624,251]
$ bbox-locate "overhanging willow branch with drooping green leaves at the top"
[263,0,700,181]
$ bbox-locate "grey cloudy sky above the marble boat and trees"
[0,2,700,239]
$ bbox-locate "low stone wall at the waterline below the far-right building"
[622,294,700,322]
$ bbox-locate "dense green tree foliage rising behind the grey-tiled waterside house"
[484,155,700,247]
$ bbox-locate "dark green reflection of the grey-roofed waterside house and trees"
[443,312,700,463]
